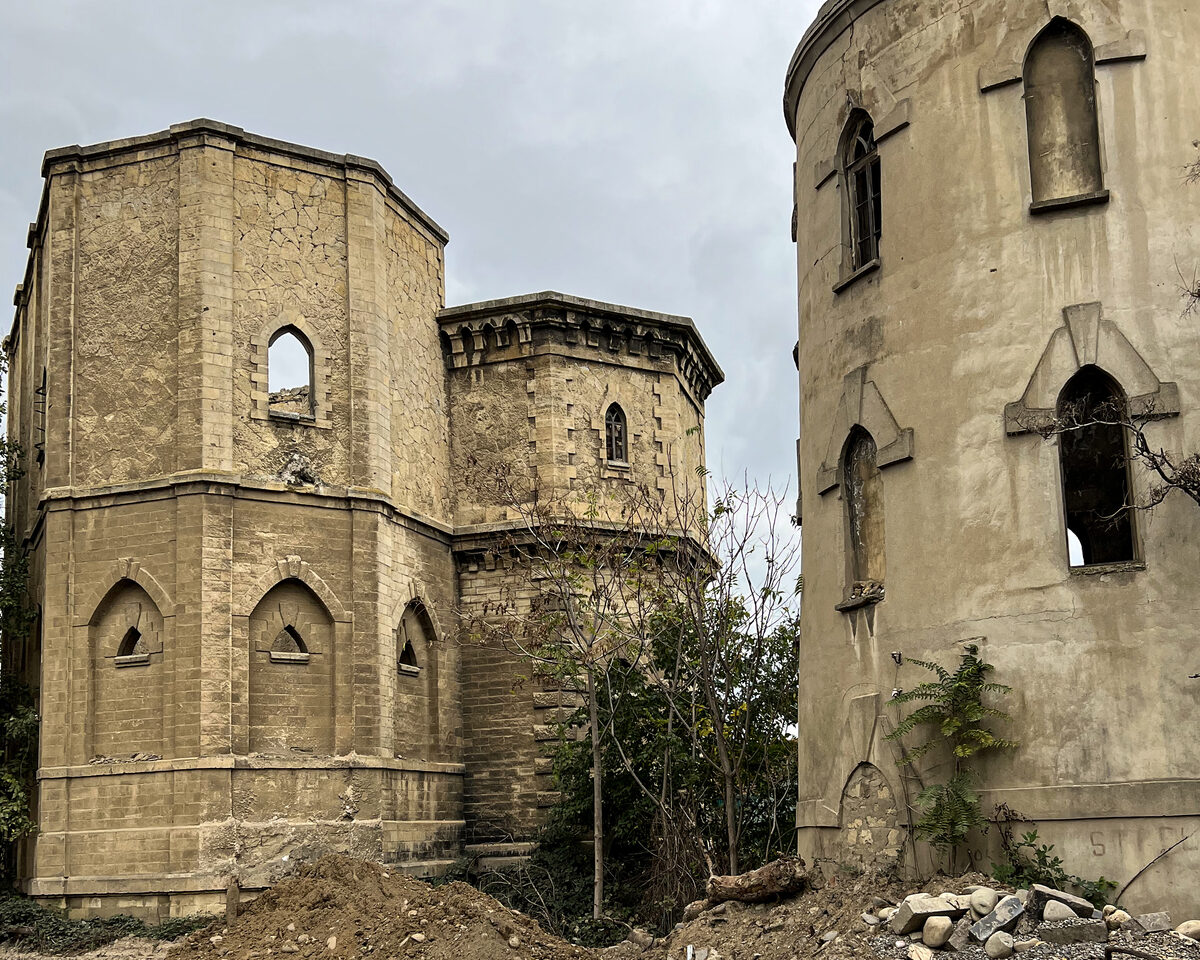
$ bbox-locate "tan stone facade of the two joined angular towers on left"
[5,121,721,914]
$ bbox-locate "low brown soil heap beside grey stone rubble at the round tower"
[633,874,1000,960]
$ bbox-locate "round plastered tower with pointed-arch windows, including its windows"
[784,0,1200,908]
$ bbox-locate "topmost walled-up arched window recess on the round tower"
[1024,18,1104,208]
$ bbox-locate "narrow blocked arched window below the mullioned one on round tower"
[841,427,884,598]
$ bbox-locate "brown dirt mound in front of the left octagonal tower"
[169,854,590,960]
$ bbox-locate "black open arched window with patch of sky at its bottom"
[1057,366,1136,566]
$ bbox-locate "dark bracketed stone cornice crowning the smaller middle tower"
[438,290,725,403]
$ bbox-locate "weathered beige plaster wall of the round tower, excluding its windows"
[788,0,1200,908]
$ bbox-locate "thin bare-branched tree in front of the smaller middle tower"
[458,451,799,918]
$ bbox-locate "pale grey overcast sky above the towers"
[0,0,817,490]
